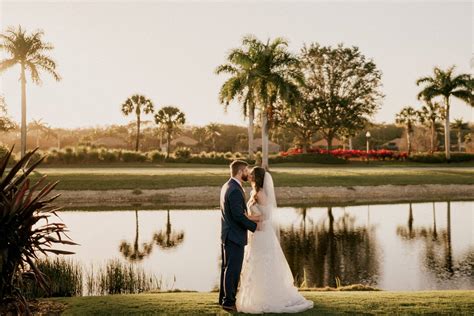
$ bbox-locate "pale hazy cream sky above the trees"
[0,0,474,128]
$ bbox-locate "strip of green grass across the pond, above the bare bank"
[29,165,474,190]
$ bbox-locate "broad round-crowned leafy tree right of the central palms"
[300,43,383,149]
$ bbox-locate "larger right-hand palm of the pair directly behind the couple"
[217,35,302,168]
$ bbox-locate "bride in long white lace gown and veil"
[236,167,313,313]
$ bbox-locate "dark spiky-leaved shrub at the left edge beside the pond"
[0,150,75,314]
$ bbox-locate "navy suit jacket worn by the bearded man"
[220,179,257,246]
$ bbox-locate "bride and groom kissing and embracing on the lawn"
[219,160,313,313]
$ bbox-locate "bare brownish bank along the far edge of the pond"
[56,184,474,210]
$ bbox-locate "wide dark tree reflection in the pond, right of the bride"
[280,207,379,287]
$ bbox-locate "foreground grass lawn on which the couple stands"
[49,291,474,315]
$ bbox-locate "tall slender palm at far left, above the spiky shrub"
[0,26,61,157]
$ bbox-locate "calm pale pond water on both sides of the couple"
[57,202,474,291]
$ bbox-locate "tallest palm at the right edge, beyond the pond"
[416,66,474,160]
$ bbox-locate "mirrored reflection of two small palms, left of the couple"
[119,210,184,262]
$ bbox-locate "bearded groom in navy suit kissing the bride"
[219,160,257,311]
